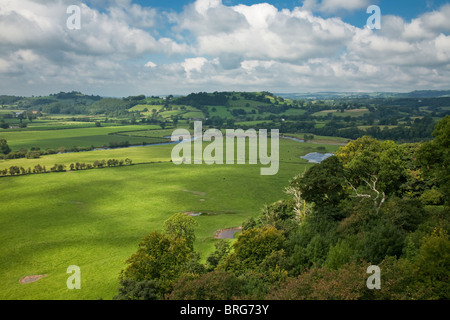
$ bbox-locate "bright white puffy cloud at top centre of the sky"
[180,0,353,67]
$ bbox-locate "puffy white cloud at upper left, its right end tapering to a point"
[0,0,185,57]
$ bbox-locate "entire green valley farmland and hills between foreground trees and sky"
[0,92,447,300]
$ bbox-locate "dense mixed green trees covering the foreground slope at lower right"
[115,116,450,300]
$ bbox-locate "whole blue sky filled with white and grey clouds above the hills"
[0,0,450,97]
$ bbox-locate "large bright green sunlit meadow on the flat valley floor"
[0,126,338,299]
